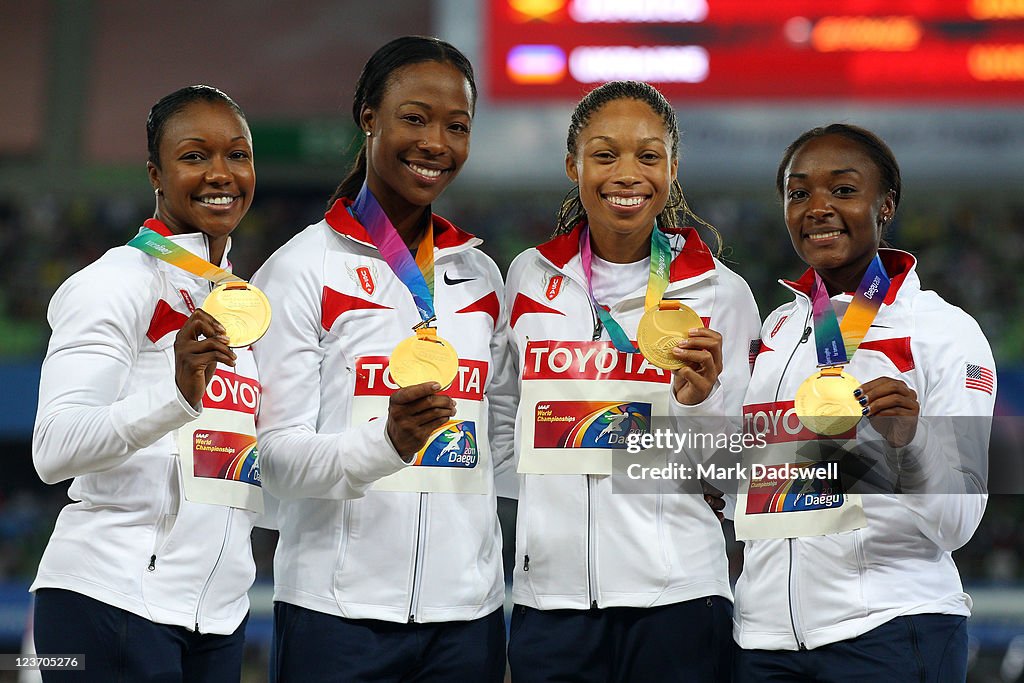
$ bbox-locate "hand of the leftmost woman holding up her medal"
[174,308,237,407]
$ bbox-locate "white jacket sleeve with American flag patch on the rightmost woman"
[895,313,995,551]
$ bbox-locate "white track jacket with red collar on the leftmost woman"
[31,220,260,634]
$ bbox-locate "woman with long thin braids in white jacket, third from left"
[507,81,760,683]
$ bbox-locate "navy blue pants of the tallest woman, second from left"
[270,602,505,683]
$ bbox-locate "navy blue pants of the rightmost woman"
[735,614,967,683]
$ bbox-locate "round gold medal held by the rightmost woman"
[794,367,863,436]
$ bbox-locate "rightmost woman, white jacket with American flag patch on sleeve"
[735,124,995,682]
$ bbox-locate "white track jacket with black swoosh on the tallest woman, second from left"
[254,200,514,623]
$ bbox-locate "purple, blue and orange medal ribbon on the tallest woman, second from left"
[349,182,434,324]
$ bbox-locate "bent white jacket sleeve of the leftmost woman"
[32,263,199,483]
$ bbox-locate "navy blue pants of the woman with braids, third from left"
[509,596,734,683]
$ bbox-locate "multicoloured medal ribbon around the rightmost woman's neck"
[811,254,890,366]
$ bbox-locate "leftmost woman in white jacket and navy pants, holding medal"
[32,86,261,683]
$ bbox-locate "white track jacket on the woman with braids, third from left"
[507,226,760,609]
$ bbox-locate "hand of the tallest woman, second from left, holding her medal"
[387,382,455,462]
